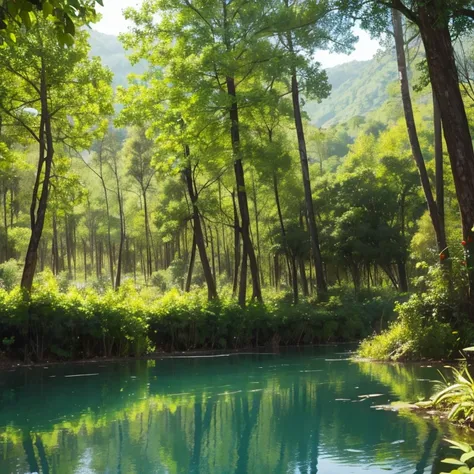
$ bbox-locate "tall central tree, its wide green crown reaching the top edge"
[120,0,284,305]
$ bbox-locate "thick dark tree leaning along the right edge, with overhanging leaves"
[339,0,474,301]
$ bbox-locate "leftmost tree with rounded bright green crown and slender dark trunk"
[0,17,111,291]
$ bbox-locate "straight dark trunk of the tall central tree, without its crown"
[226,77,262,306]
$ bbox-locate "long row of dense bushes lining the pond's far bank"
[0,282,391,360]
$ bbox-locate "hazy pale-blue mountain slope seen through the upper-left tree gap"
[89,30,146,87]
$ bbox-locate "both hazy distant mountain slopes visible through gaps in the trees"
[90,30,397,127]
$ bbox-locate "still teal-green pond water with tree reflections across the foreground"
[0,347,468,474]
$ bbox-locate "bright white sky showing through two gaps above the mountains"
[93,0,379,68]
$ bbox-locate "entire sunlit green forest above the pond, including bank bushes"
[0,0,474,361]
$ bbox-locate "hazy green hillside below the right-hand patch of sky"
[305,54,398,127]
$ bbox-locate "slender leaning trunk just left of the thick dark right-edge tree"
[392,10,449,261]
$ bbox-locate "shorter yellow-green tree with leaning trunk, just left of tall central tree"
[119,68,219,300]
